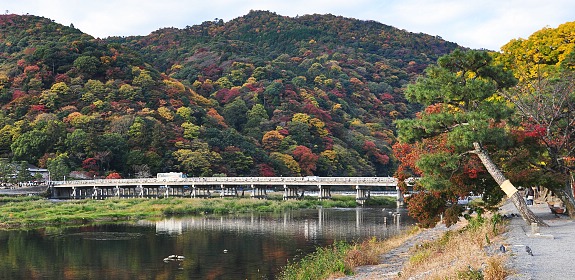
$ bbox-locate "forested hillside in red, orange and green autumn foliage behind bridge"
[0,11,457,179]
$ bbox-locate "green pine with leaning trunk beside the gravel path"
[396,50,545,225]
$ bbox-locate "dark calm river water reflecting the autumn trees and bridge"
[0,208,413,279]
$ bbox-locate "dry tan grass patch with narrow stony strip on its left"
[337,211,508,280]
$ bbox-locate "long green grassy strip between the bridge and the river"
[0,196,395,229]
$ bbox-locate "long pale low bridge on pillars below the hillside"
[51,176,397,204]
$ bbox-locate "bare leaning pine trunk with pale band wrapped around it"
[472,142,549,227]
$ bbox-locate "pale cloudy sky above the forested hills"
[4,0,575,50]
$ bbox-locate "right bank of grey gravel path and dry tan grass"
[330,201,575,280]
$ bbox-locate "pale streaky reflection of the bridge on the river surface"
[138,207,409,240]
